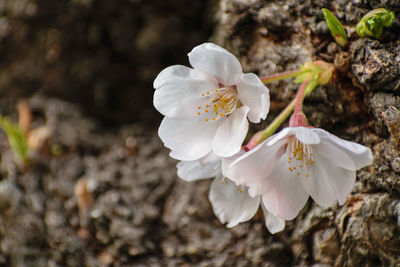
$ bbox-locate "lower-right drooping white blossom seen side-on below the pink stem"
[223,127,373,220]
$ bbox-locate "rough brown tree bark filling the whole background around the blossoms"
[0,0,400,266]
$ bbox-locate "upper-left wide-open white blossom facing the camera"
[154,43,270,161]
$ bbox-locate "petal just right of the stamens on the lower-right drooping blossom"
[301,150,356,207]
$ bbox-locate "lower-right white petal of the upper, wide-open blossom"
[212,106,249,157]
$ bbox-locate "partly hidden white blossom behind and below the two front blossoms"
[177,153,285,234]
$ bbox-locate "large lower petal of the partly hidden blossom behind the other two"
[208,177,260,227]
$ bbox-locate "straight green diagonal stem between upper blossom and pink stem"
[256,80,318,144]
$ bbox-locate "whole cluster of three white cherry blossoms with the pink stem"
[154,43,373,233]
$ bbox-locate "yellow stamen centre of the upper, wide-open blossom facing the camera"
[197,86,238,121]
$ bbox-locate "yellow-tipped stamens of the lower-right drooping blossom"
[286,138,314,178]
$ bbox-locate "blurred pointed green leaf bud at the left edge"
[0,117,29,163]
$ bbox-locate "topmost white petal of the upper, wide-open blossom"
[188,43,243,86]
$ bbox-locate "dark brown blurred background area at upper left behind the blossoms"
[0,0,213,125]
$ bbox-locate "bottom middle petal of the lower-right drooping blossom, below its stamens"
[262,155,309,220]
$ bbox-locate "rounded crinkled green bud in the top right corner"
[356,8,395,38]
